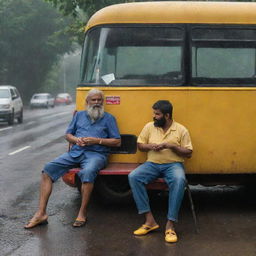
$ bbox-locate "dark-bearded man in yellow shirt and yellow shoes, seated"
[129,100,192,243]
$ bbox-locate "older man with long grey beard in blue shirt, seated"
[25,89,121,229]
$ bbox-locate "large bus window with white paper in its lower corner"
[81,25,185,86]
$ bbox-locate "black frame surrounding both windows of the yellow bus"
[78,23,256,88]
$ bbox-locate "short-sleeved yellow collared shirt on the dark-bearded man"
[138,121,193,164]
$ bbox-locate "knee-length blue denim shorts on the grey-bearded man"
[43,151,107,183]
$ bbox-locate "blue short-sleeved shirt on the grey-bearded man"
[66,111,120,157]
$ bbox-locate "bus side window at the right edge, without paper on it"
[192,27,256,86]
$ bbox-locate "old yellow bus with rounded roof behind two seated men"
[63,1,256,202]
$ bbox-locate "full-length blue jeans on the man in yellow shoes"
[128,162,186,221]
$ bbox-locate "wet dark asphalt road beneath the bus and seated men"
[0,106,256,256]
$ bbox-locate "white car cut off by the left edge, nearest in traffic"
[0,85,23,125]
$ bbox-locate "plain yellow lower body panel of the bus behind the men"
[77,87,256,174]
